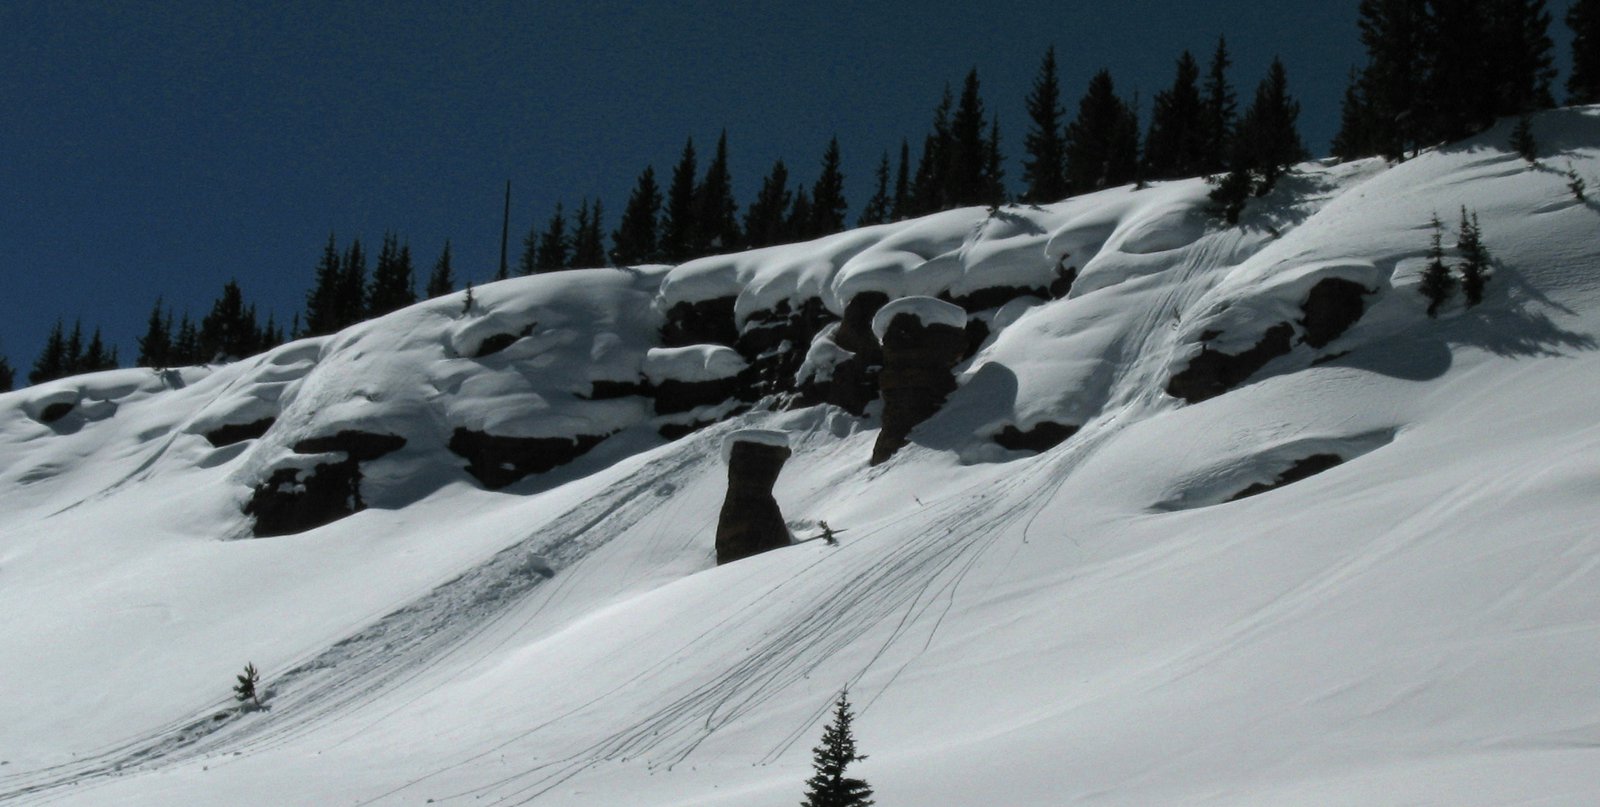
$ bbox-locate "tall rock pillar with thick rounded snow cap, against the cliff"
[872,296,966,464]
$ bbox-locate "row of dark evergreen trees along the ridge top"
[0,0,1600,389]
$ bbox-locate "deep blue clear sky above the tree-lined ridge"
[0,0,1566,374]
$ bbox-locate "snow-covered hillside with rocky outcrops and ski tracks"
[0,107,1600,807]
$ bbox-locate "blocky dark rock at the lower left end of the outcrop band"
[245,458,366,538]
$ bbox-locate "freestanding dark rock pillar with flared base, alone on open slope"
[717,440,790,565]
